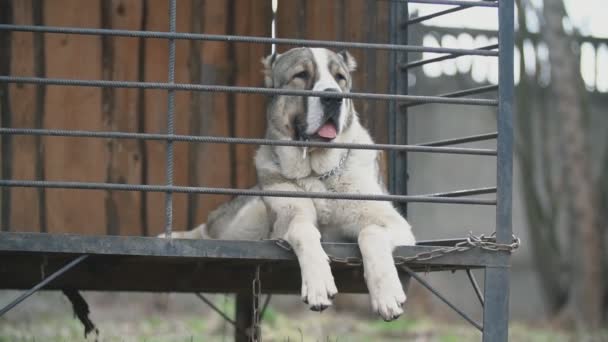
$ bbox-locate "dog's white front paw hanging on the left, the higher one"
[302,262,338,311]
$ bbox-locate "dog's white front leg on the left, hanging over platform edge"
[264,184,338,311]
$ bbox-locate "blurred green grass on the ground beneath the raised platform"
[0,308,608,342]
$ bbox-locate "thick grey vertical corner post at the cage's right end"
[483,0,514,342]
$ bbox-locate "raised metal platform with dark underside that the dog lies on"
[0,233,508,294]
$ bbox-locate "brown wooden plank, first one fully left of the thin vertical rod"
[101,0,143,235]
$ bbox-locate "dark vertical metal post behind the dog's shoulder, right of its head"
[388,1,409,215]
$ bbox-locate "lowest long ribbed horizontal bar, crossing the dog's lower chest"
[0,179,496,205]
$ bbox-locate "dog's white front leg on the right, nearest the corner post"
[358,225,414,321]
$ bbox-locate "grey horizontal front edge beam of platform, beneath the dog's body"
[0,231,507,268]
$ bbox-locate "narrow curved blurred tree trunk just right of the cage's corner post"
[515,0,568,312]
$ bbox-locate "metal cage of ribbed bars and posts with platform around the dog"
[0,0,516,341]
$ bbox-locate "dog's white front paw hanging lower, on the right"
[368,271,406,322]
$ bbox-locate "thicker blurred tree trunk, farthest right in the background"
[543,1,603,328]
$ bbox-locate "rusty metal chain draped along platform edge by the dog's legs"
[276,233,521,266]
